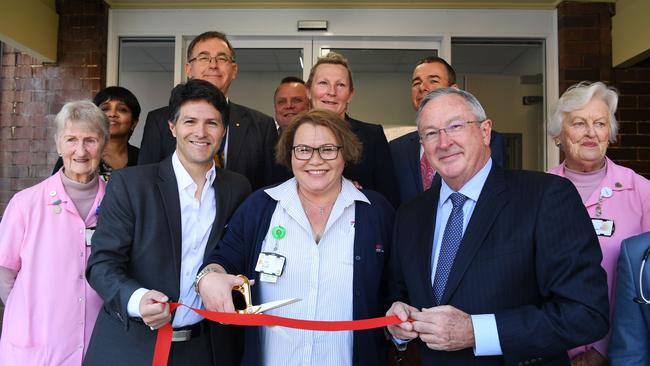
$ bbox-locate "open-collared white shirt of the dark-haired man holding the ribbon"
[128,152,217,328]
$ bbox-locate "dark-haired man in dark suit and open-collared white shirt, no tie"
[84,80,250,366]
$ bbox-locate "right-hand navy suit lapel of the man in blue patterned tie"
[440,164,507,304]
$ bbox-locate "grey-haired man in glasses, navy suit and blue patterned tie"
[388,88,608,365]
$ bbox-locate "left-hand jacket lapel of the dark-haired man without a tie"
[157,156,182,286]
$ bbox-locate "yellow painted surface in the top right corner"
[612,0,650,66]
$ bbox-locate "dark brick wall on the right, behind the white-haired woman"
[558,2,650,178]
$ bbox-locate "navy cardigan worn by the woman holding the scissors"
[205,189,394,366]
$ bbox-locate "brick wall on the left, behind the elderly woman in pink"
[0,0,108,325]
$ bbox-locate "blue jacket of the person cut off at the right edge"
[609,232,650,366]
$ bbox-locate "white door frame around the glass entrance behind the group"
[106,9,559,168]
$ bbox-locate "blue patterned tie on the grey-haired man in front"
[433,192,467,304]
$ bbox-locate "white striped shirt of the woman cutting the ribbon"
[256,178,370,366]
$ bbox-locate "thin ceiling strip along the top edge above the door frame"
[104,0,616,9]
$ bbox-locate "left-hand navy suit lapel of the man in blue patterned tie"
[415,180,440,305]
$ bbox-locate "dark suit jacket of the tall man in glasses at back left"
[138,102,278,189]
